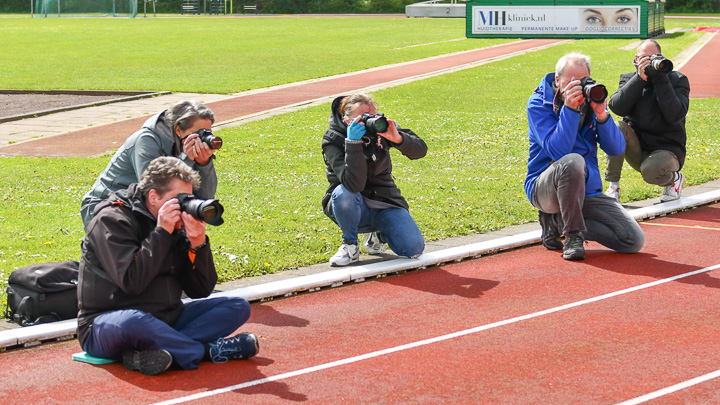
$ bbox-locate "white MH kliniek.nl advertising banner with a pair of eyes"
[471,5,640,36]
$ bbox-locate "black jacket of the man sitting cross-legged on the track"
[78,184,217,345]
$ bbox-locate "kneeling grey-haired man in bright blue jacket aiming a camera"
[525,53,645,260]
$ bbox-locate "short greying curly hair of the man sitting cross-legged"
[138,156,200,198]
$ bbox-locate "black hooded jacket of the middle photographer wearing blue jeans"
[322,96,427,221]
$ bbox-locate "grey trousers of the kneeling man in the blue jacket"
[532,153,645,253]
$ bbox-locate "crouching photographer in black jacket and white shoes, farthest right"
[605,39,690,202]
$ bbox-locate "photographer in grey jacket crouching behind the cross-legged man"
[80,100,222,230]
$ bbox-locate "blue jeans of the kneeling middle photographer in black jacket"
[332,184,425,257]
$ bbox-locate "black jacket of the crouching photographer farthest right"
[608,71,690,168]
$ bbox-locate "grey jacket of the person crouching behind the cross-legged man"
[80,111,217,229]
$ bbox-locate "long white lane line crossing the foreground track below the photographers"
[150,264,720,405]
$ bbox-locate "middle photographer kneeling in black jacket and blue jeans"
[322,94,427,266]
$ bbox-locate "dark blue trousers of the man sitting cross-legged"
[83,297,250,370]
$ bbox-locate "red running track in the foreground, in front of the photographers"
[0,205,720,404]
